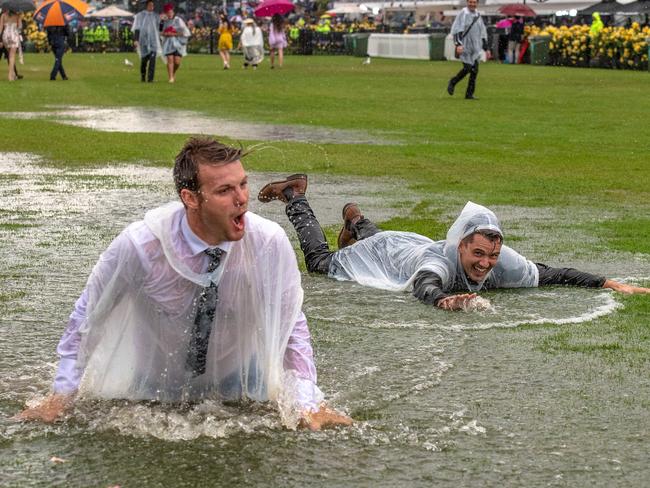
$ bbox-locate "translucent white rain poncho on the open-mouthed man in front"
[77,203,303,408]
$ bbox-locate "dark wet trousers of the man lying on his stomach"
[286,196,381,274]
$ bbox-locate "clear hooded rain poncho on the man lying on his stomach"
[329,202,539,292]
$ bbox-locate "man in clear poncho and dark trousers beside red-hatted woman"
[131,0,162,83]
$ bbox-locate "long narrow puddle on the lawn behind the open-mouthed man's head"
[0,106,400,145]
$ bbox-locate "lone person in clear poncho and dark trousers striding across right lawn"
[447,0,488,100]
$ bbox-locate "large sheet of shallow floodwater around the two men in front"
[0,153,650,487]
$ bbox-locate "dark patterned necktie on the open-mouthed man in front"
[187,248,224,376]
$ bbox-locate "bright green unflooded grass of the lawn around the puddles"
[0,54,650,366]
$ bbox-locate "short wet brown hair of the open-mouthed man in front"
[174,137,248,196]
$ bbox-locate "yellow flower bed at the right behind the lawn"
[526,22,650,69]
